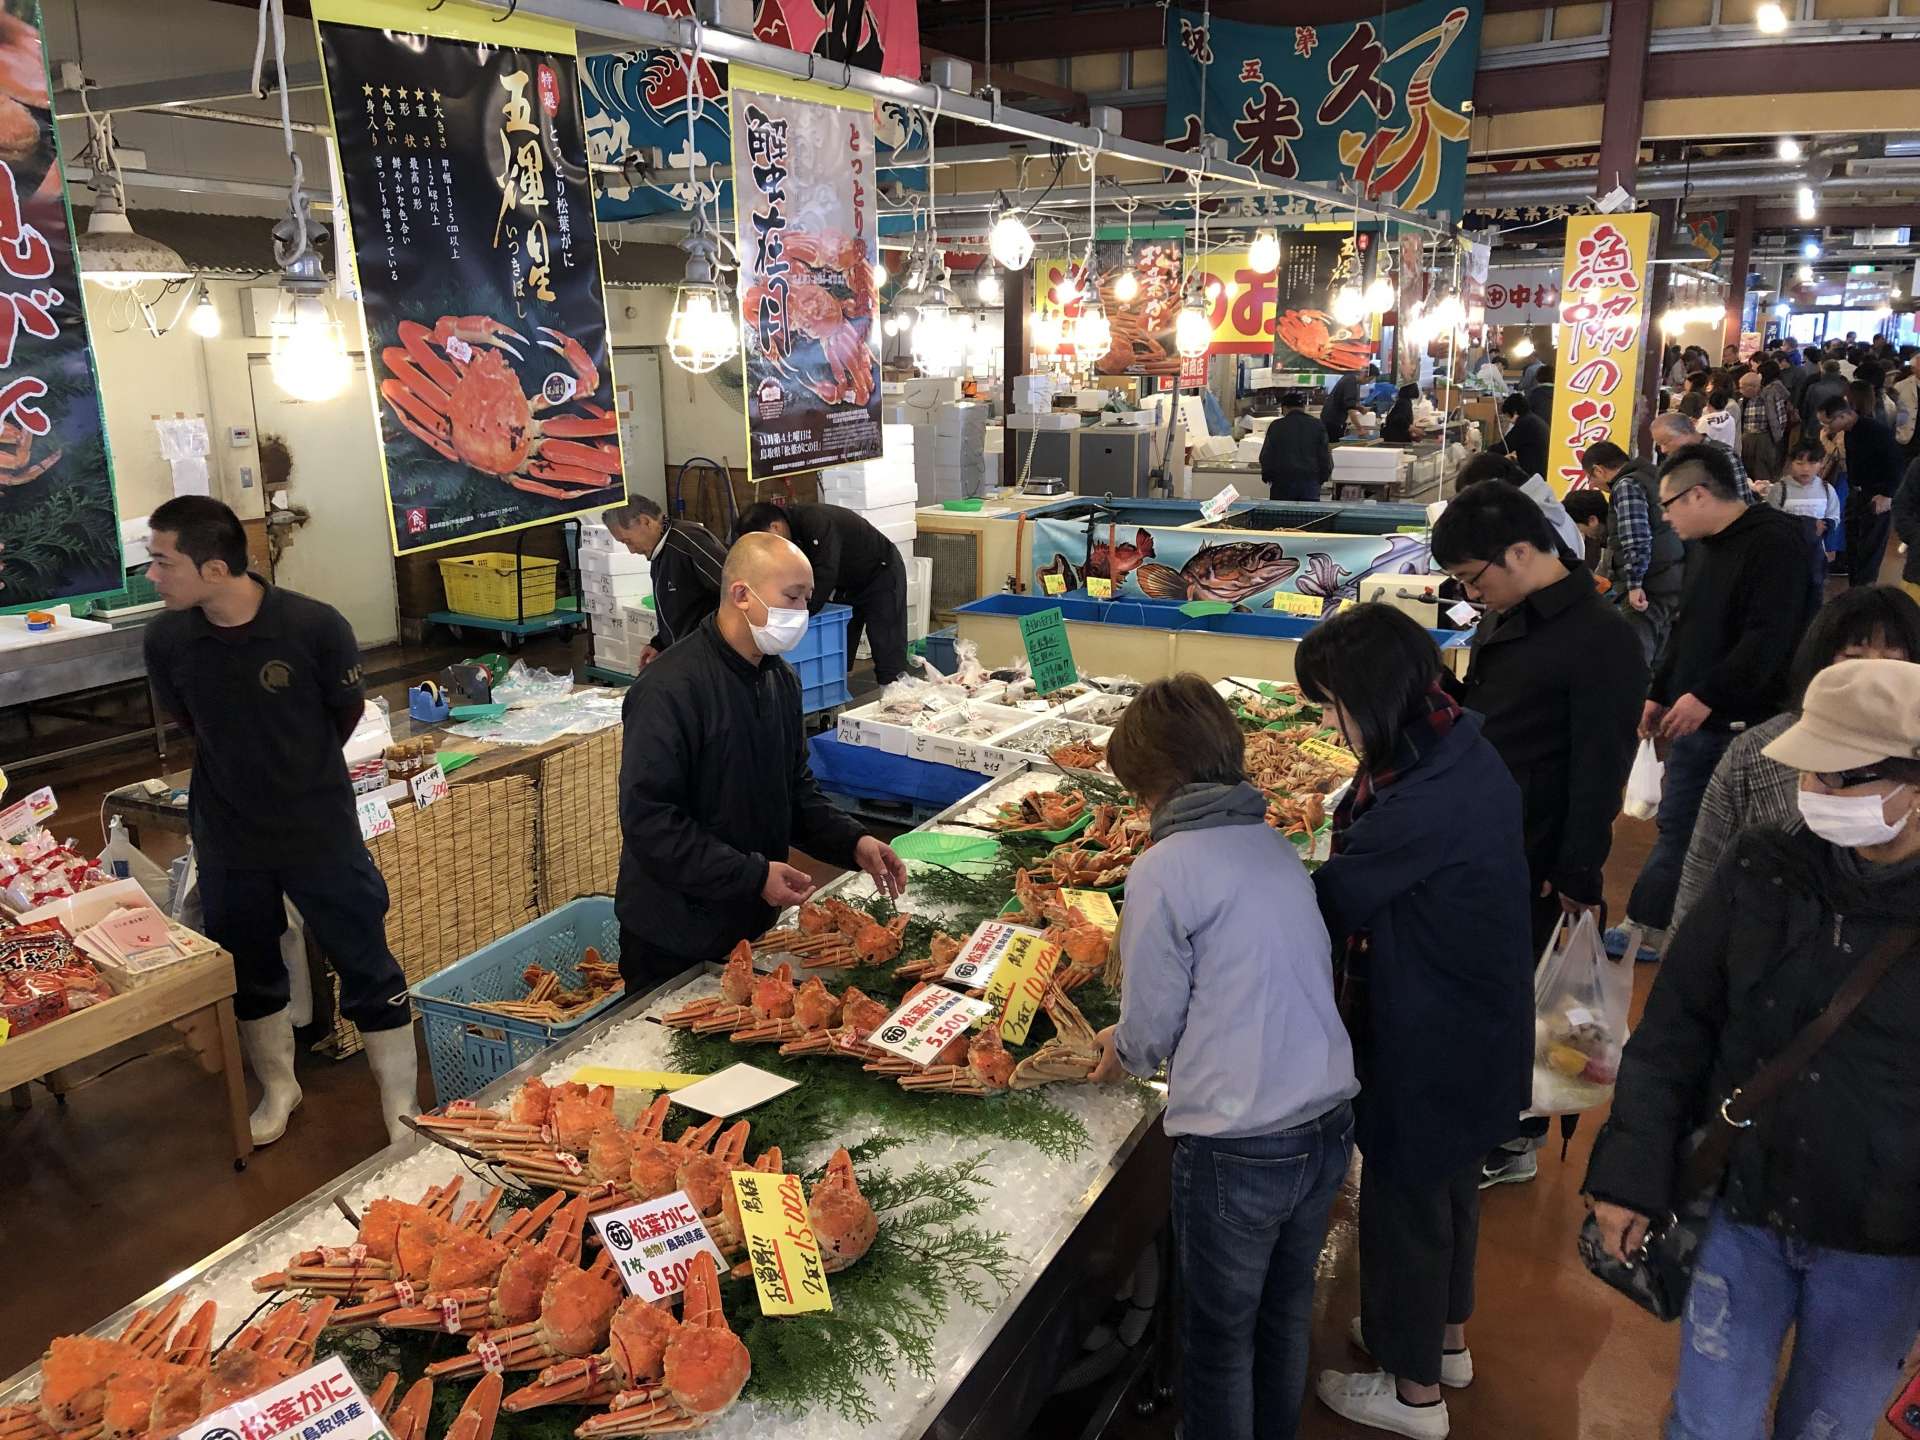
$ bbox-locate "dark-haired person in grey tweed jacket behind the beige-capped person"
[1672,586,1920,929]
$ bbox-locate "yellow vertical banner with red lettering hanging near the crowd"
[1546,211,1653,495]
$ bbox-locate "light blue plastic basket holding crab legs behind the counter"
[411,895,620,1104]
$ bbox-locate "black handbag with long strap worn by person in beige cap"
[1576,925,1920,1321]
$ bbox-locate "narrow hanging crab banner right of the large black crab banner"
[732,65,879,482]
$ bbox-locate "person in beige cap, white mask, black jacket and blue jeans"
[1586,660,1920,1440]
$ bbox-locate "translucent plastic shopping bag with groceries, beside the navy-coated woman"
[1528,910,1634,1116]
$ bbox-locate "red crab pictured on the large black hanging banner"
[380,315,620,499]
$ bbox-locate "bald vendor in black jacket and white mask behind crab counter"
[614,534,906,995]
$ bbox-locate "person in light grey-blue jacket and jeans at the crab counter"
[1092,674,1359,1440]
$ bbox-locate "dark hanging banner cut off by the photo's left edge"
[0,4,125,609]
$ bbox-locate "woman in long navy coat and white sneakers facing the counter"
[1282,605,1534,1440]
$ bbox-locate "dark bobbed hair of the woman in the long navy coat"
[1290,602,1457,770]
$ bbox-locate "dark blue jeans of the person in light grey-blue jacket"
[1173,1100,1354,1440]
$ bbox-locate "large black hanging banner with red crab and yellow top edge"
[313,0,626,555]
